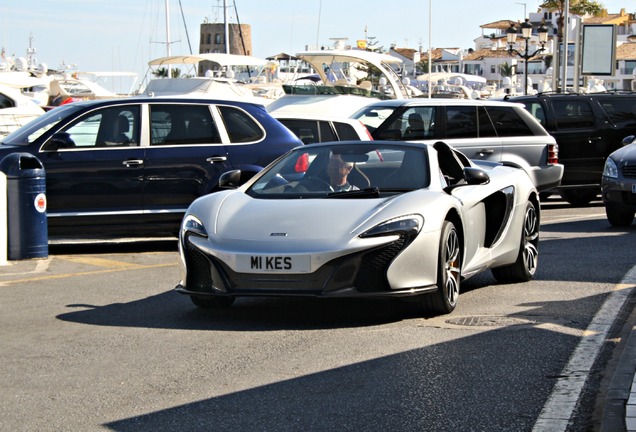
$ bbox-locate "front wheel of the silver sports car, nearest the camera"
[422,221,461,315]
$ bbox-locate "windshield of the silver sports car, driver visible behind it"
[247,142,430,199]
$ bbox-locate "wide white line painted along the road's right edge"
[532,266,636,432]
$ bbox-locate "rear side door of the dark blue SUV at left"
[144,102,231,226]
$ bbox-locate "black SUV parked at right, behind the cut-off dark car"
[509,93,636,205]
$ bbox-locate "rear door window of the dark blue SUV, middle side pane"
[150,104,221,145]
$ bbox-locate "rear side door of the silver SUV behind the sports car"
[435,105,502,162]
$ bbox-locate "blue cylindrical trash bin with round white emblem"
[0,153,49,260]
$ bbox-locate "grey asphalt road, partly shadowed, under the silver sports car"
[0,200,636,431]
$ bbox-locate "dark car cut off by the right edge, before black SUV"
[601,135,636,227]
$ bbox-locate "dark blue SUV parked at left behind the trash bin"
[0,97,302,237]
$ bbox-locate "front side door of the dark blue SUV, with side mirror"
[38,104,144,231]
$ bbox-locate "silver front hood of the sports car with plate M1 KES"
[189,190,439,252]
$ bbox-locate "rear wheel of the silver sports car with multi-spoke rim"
[491,201,539,283]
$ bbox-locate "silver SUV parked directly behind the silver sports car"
[352,98,563,191]
